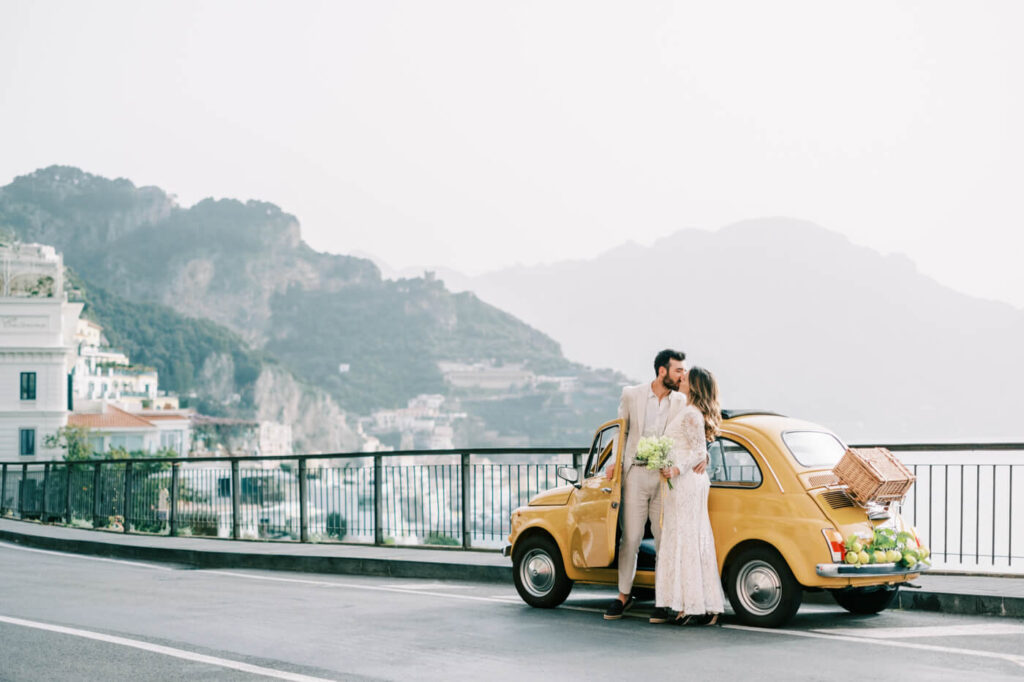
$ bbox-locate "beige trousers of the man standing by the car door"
[618,465,664,594]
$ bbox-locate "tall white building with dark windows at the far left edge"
[0,244,82,462]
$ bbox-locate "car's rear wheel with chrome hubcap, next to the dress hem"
[725,547,803,628]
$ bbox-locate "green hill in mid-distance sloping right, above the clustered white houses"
[265,280,572,414]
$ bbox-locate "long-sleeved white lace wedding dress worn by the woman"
[654,406,724,615]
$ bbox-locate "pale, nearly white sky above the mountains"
[6,0,1024,308]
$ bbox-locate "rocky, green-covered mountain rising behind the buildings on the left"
[0,166,622,445]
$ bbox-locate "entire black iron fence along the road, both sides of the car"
[0,443,1024,571]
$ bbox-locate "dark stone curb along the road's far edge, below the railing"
[0,520,1024,619]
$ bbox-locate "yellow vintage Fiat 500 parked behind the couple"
[504,411,922,627]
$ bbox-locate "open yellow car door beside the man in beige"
[567,419,626,568]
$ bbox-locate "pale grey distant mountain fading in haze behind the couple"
[428,218,1024,441]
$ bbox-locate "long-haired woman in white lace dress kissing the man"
[654,367,724,625]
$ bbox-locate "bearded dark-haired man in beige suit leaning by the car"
[604,348,707,623]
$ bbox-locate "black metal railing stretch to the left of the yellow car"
[0,447,586,549]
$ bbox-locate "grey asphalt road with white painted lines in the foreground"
[0,543,1024,682]
